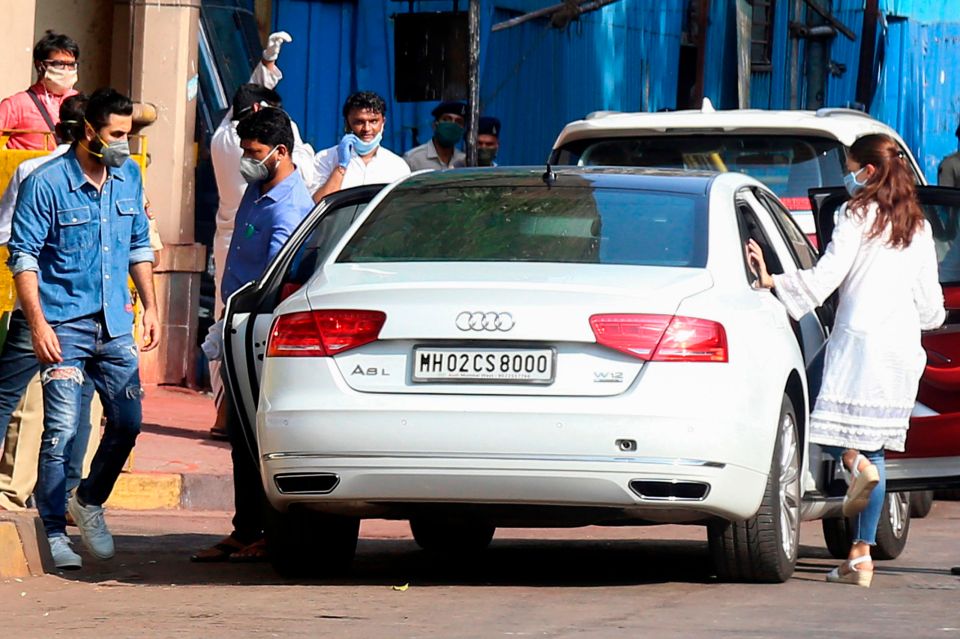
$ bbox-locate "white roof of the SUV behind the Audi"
[554,100,906,148]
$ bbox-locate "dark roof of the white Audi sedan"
[396,166,718,195]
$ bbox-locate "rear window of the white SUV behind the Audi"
[555,134,845,199]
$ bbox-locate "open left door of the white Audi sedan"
[223,184,386,465]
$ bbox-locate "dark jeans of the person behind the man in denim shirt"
[0,311,94,500]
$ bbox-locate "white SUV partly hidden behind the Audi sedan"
[550,99,926,243]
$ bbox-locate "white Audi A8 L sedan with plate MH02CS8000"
[226,167,952,581]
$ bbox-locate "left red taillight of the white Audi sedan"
[267,310,387,357]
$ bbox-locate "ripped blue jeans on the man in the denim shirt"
[35,316,143,537]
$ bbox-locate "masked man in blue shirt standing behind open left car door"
[191,108,313,562]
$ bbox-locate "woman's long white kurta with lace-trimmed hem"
[773,204,945,451]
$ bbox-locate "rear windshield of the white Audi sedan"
[337,186,707,267]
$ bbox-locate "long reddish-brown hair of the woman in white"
[848,134,924,248]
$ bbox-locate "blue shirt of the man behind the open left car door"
[220,171,315,303]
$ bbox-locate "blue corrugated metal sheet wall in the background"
[273,0,960,177]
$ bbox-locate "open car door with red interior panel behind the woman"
[810,185,960,491]
